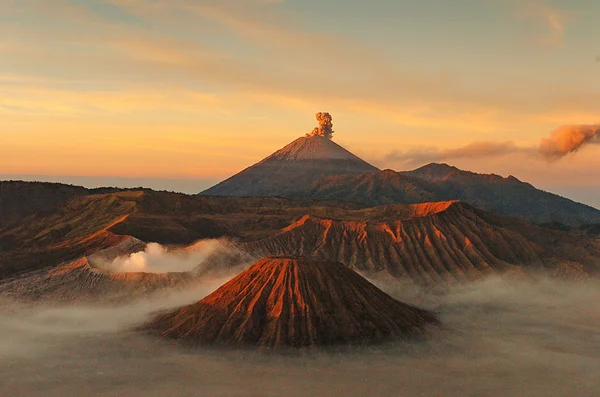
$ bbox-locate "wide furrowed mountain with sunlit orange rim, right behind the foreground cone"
[245,202,600,284]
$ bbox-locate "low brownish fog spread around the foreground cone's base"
[0,277,600,397]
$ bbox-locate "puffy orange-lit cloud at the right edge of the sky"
[539,124,600,161]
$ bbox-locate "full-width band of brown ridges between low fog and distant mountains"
[0,184,600,282]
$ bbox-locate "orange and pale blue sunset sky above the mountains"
[0,0,600,207]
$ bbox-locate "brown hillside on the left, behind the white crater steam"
[0,184,366,279]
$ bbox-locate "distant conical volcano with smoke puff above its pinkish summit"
[201,135,377,197]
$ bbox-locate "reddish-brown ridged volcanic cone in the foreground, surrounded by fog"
[145,257,437,348]
